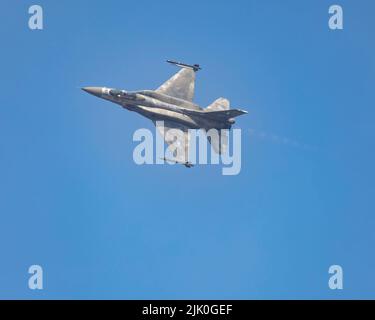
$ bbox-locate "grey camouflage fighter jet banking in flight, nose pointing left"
[82,60,247,168]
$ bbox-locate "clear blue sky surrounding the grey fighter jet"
[0,0,375,299]
